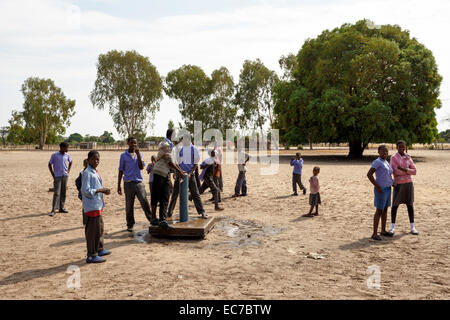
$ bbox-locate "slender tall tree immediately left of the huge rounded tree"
[235,59,279,133]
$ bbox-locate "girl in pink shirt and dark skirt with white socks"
[389,140,419,236]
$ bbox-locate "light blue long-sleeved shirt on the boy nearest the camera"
[81,165,105,217]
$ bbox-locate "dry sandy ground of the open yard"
[0,150,450,300]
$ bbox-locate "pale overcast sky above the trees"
[0,0,450,138]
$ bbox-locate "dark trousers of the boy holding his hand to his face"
[123,181,152,228]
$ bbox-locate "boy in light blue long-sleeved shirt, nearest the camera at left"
[81,150,111,263]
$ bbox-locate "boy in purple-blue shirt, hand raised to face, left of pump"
[117,137,152,232]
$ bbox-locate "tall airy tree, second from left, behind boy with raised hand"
[90,50,162,136]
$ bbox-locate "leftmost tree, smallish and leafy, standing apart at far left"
[16,78,75,149]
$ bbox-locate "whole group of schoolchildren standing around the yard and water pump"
[49,134,418,263]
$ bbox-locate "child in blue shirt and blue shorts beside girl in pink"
[367,145,394,241]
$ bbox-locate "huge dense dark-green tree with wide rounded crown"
[274,20,442,157]
